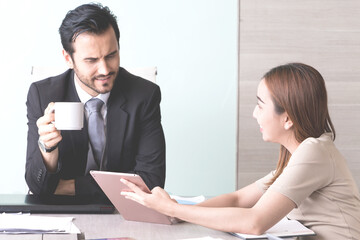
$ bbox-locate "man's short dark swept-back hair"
[59,3,120,56]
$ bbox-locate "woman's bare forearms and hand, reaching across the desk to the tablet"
[121,179,295,234]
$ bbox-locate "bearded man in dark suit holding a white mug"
[25,4,165,200]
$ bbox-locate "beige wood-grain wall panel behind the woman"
[238,0,360,187]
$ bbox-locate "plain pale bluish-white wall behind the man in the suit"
[0,0,238,195]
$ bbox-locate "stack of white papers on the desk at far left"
[0,213,80,234]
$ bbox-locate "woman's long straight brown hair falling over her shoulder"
[263,63,335,186]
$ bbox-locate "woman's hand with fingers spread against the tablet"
[120,178,177,216]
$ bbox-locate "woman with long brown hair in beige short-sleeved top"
[121,63,360,239]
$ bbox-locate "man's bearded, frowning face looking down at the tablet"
[63,27,120,97]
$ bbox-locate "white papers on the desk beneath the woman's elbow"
[232,217,315,239]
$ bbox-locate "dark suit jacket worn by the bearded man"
[25,67,165,199]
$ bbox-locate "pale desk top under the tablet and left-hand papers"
[0,214,239,240]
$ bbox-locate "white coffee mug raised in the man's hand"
[54,102,84,130]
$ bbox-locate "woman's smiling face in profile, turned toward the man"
[253,79,287,144]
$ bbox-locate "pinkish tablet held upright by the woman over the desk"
[90,170,176,224]
